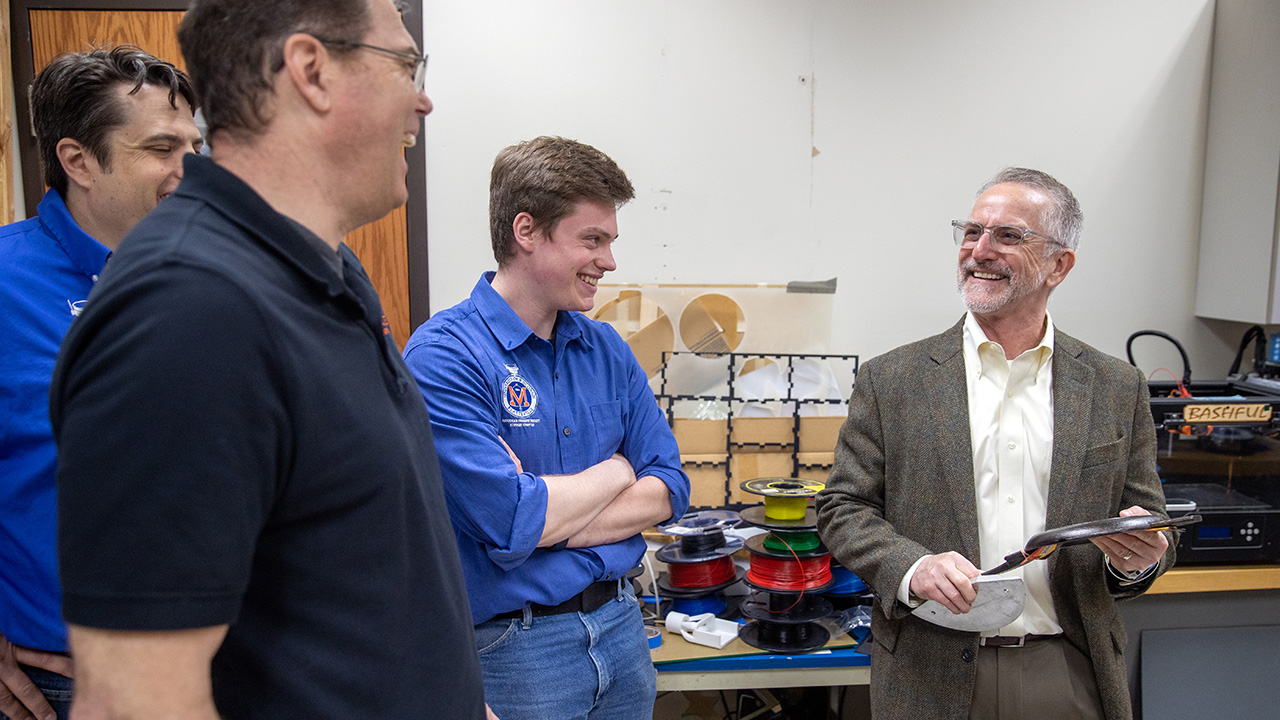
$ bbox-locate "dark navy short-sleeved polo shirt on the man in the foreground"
[50,155,484,720]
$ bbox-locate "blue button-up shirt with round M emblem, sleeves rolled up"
[404,272,689,624]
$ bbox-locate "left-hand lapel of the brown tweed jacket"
[920,318,979,562]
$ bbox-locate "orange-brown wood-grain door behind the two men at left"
[14,3,426,348]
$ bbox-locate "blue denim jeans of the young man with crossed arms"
[476,583,658,720]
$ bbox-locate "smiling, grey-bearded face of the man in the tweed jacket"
[956,183,1074,319]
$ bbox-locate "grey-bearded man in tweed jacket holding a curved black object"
[817,168,1172,720]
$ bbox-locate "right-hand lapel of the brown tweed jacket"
[1044,331,1093,529]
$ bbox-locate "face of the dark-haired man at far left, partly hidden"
[77,85,204,247]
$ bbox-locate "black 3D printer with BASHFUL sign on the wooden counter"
[1129,328,1280,564]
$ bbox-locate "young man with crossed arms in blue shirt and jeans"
[404,137,689,720]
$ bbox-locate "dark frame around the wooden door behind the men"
[5,0,431,320]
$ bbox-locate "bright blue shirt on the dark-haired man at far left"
[0,190,110,652]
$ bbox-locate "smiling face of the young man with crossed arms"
[517,200,618,313]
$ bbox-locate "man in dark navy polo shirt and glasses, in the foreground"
[51,0,485,720]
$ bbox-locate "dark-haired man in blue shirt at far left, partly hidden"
[0,46,201,720]
